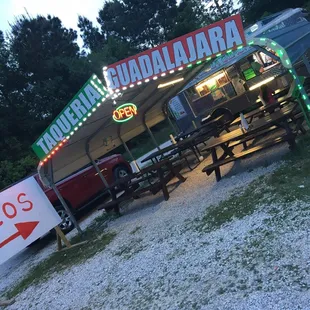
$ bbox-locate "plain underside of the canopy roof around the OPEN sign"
[53,64,204,182]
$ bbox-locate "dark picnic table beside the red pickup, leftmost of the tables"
[98,159,186,213]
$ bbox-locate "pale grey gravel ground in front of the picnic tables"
[0,145,310,310]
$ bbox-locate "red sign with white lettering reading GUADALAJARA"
[104,15,246,90]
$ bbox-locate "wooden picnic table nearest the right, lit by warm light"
[202,106,302,181]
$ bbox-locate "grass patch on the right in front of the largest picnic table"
[194,134,310,232]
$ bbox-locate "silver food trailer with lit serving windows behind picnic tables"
[168,13,310,132]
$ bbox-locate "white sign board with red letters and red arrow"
[0,177,61,264]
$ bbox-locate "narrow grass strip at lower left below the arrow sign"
[6,214,115,299]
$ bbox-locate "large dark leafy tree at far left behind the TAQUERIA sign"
[0,16,91,188]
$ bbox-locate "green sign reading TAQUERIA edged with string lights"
[32,75,108,161]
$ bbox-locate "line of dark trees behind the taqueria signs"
[0,0,304,189]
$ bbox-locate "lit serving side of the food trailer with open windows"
[185,48,289,116]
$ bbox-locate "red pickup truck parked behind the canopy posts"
[35,155,132,232]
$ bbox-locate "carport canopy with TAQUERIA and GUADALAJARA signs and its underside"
[32,15,252,182]
